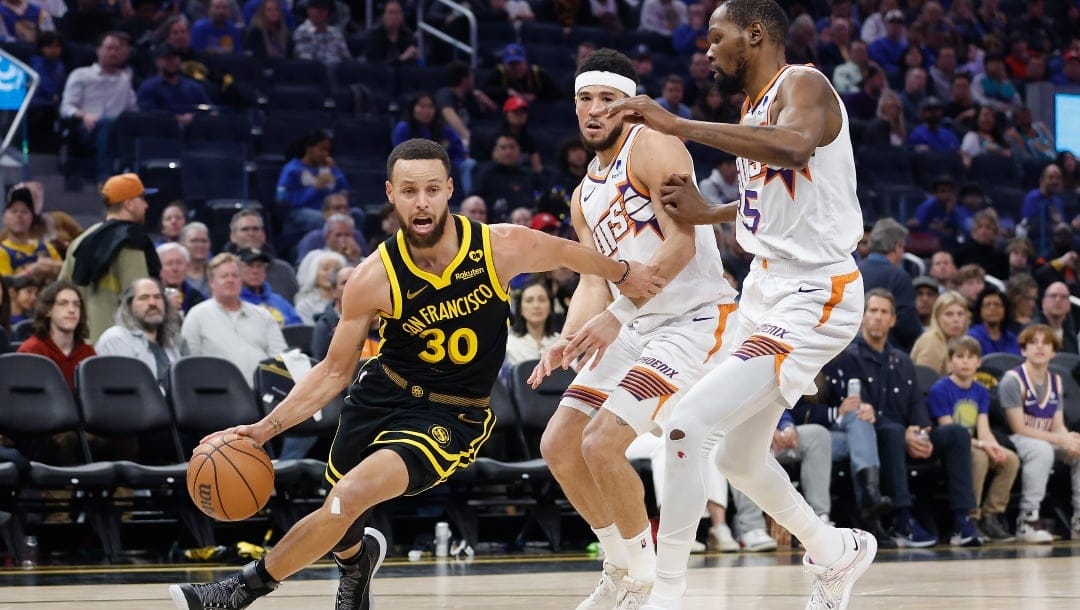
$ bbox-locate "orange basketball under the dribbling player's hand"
[188,434,273,521]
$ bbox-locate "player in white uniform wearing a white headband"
[530,49,735,609]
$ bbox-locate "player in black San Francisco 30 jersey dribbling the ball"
[170,139,664,610]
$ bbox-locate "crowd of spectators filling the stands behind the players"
[0,0,1080,551]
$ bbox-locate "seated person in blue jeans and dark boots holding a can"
[793,355,896,547]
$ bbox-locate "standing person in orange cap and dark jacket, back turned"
[60,174,161,342]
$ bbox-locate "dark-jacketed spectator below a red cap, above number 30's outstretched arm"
[472,134,540,213]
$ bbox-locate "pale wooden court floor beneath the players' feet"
[0,543,1080,610]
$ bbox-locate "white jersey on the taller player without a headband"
[735,66,863,265]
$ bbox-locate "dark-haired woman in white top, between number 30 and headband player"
[507,276,558,366]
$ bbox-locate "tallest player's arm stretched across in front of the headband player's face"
[608,70,839,170]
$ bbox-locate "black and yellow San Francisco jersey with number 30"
[354,215,510,402]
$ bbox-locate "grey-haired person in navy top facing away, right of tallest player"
[859,218,922,350]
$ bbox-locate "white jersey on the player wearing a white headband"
[581,125,735,315]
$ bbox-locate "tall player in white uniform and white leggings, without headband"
[609,0,877,609]
